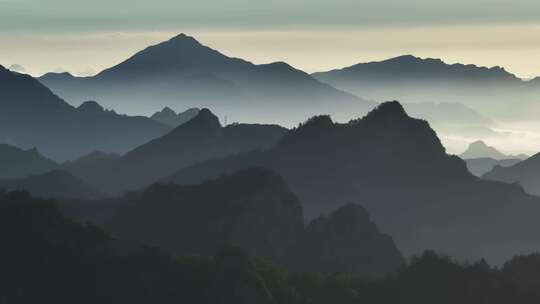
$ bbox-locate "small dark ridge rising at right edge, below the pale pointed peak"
[483,154,540,195]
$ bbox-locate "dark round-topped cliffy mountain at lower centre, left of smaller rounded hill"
[109,169,304,258]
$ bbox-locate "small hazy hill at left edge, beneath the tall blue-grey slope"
[0,144,58,179]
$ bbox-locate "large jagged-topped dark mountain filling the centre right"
[165,102,540,262]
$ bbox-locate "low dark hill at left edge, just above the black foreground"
[0,170,103,199]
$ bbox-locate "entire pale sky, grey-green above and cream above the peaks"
[0,0,540,78]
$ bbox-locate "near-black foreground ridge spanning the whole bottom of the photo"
[11,192,540,304]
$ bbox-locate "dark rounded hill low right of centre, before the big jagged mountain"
[285,204,404,277]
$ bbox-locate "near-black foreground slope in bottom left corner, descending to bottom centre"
[0,192,286,304]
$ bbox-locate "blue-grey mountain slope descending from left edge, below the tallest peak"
[0,66,169,160]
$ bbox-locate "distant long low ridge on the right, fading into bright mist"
[313,55,540,120]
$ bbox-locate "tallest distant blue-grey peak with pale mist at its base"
[40,34,374,125]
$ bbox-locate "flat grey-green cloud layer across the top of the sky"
[0,0,540,30]
